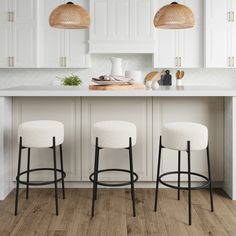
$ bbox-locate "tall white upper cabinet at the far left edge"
[0,0,37,68]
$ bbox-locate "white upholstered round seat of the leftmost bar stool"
[18,120,64,148]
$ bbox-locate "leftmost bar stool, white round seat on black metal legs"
[15,120,66,215]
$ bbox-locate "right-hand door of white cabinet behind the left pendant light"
[65,0,91,68]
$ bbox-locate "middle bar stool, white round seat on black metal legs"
[89,121,138,217]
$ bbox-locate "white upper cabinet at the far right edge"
[205,0,236,68]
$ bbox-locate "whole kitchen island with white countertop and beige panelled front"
[0,86,236,200]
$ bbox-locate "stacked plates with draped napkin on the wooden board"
[92,75,134,85]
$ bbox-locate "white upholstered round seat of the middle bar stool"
[92,121,137,149]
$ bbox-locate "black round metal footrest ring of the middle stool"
[89,169,138,187]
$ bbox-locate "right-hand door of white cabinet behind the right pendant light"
[178,0,204,68]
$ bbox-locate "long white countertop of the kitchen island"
[0,86,236,97]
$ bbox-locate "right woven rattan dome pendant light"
[154,2,195,29]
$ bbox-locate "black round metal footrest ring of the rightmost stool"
[159,171,210,190]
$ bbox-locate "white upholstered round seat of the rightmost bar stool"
[161,122,208,151]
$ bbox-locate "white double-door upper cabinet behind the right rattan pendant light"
[153,0,204,68]
